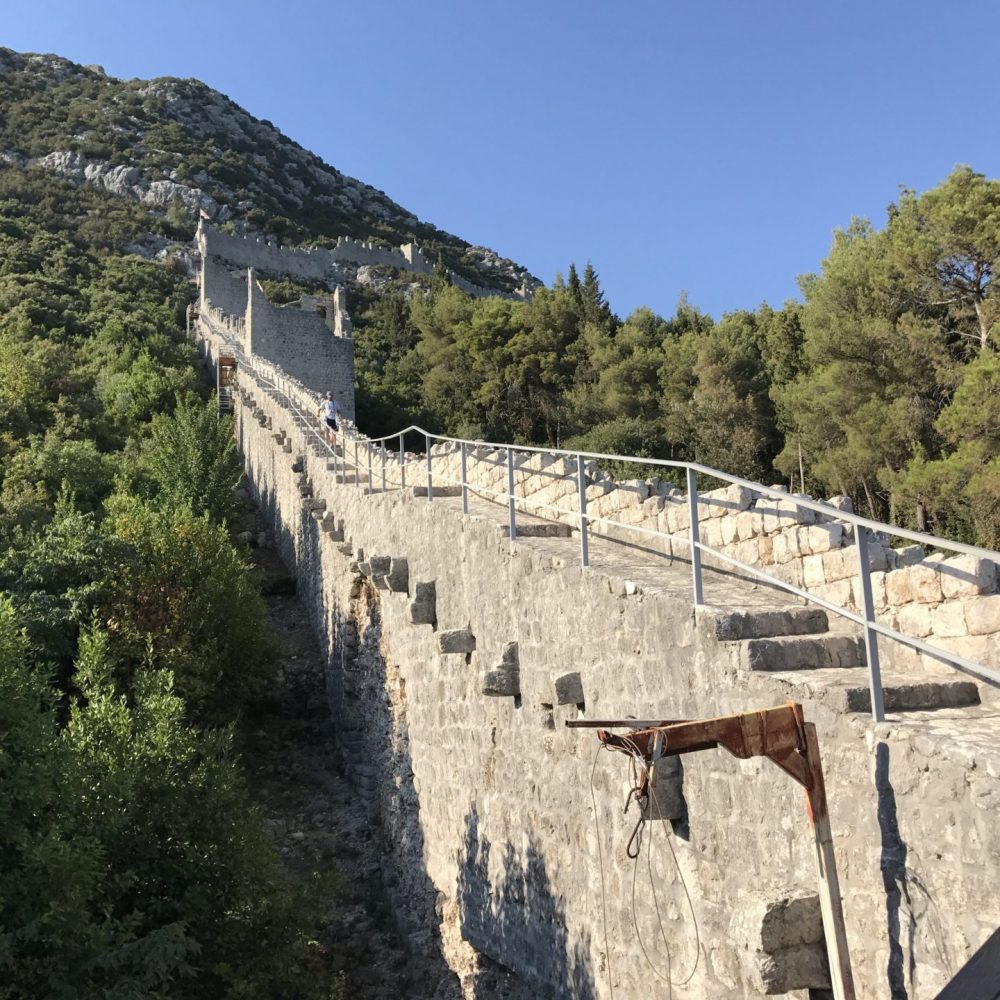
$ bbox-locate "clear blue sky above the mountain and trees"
[0,0,1000,316]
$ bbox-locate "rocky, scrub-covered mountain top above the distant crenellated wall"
[0,48,537,290]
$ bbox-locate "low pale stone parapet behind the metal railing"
[411,445,1000,670]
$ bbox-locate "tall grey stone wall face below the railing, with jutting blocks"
[199,324,1000,1000]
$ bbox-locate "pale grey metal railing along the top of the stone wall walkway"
[197,316,1000,722]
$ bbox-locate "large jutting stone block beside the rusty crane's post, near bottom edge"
[730,888,830,994]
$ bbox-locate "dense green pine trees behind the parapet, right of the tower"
[356,167,1000,544]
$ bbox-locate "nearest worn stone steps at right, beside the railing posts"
[702,607,980,714]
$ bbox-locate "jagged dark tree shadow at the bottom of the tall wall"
[458,803,595,1000]
